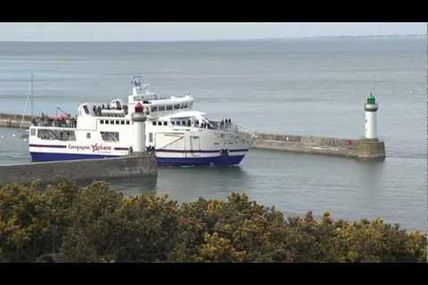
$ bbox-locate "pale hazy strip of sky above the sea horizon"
[0,23,427,41]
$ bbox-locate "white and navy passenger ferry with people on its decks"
[29,77,255,165]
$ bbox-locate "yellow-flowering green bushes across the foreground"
[0,181,427,262]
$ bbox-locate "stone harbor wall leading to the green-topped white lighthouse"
[253,133,385,159]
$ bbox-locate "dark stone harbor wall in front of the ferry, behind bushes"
[0,153,157,185]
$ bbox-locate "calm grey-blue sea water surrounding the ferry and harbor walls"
[0,37,427,230]
